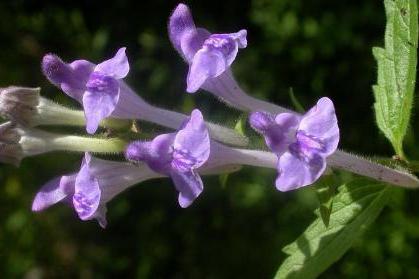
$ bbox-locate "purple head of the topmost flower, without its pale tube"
[168,4,247,93]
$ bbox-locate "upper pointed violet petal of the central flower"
[172,109,210,172]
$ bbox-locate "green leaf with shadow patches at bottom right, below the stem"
[275,179,391,279]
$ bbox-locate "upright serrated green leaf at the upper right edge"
[372,0,418,158]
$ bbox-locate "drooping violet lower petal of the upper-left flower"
[83,72,120,134]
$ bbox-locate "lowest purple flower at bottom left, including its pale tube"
[32,153,161,228]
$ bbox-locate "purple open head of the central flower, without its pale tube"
[125,109,210,208]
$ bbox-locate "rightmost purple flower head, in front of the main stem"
[249,98,339,191]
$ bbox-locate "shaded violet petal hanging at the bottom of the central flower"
[171,171,204,208]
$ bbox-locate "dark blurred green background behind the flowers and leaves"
[0,0,419,278]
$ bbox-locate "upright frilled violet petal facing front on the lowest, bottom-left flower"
[73,153,101,220]
